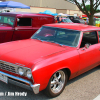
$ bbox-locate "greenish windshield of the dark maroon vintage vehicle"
[0,16,15,26]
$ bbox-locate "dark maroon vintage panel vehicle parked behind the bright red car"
[0,12,55,43]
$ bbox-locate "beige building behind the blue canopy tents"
[2,0,82,16]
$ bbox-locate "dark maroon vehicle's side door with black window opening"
[12,17,33,41]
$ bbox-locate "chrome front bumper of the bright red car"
[0,71,40,94]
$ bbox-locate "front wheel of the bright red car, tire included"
[45,70,68,97]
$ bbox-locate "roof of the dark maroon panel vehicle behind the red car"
[0,12,54,17]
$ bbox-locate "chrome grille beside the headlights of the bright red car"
[0,61,16,73]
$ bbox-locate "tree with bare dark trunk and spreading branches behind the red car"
[66,0,100,25]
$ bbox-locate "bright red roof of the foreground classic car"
[44,23,100,31]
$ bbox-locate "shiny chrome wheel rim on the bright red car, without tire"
[51,70,65,93]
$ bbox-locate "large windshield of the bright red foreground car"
[32,26,80,47]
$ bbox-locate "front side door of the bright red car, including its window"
[78,31,100,74]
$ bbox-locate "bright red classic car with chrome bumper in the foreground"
[0,23,100,97]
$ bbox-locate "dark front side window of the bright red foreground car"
[80,31,98,48]
